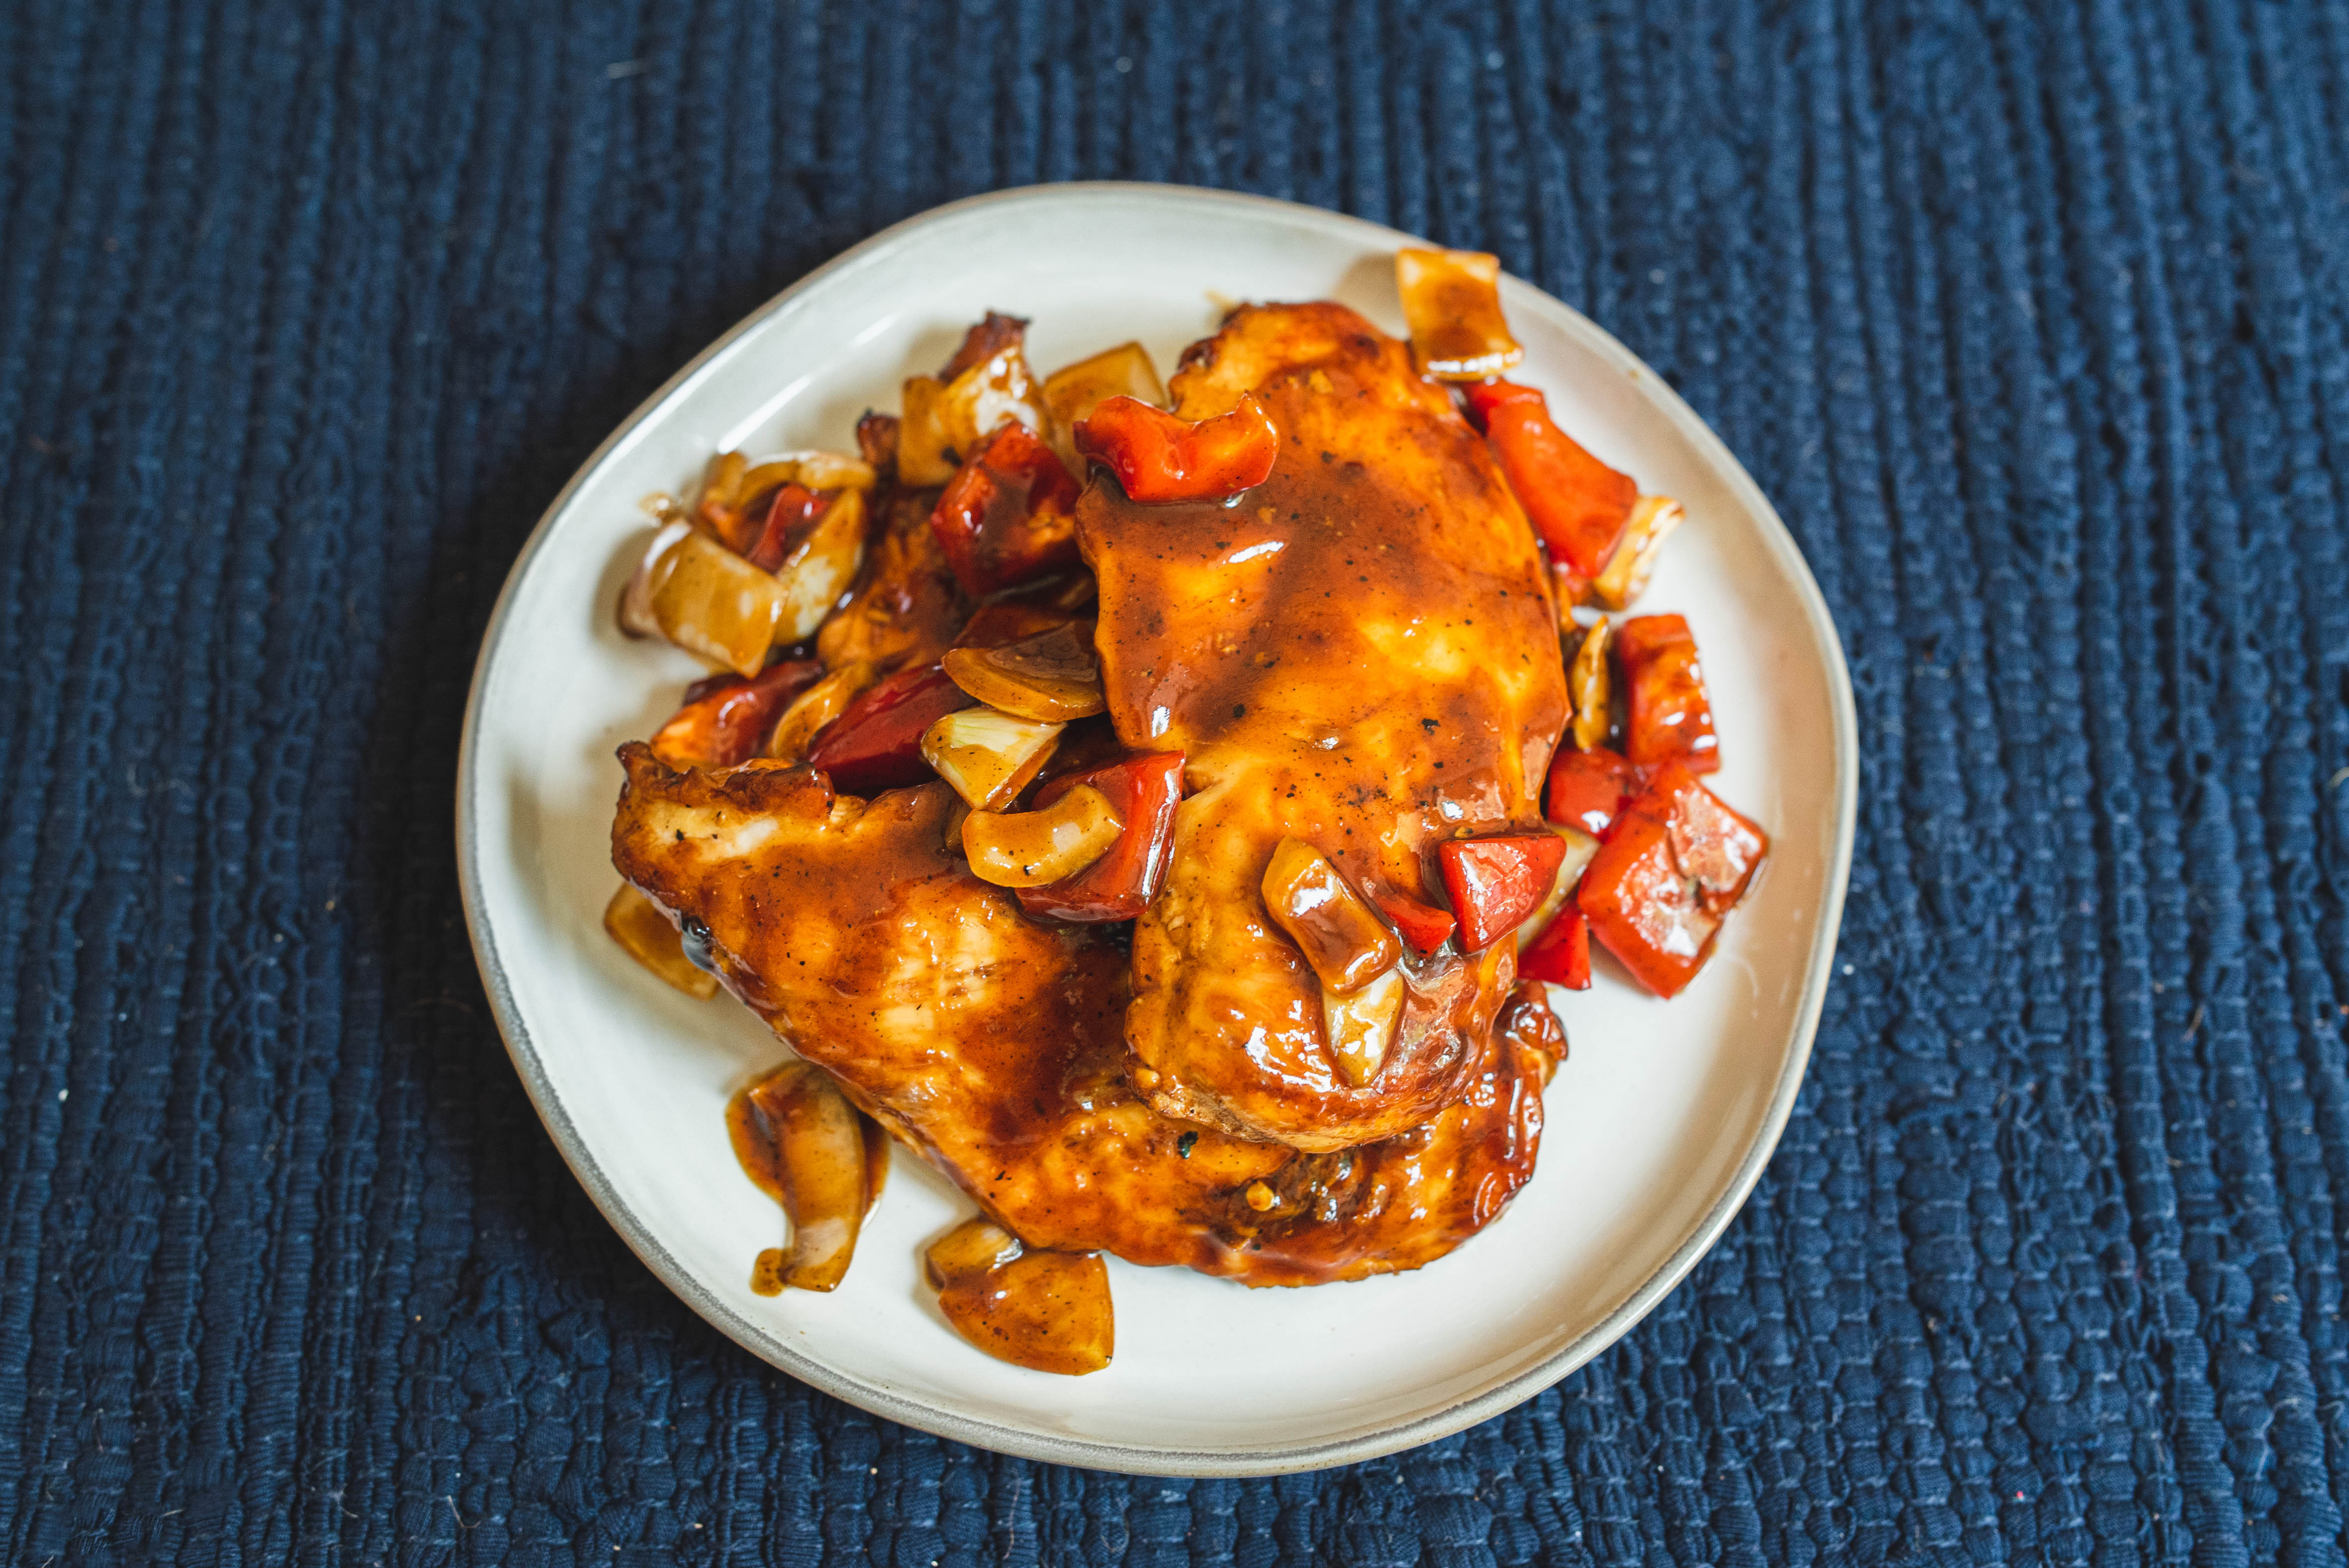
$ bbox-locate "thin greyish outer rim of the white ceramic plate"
[456,181,1858,1476]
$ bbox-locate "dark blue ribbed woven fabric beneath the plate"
[0,0,2349,1568]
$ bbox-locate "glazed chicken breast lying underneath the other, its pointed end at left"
[613,744,1550,1284]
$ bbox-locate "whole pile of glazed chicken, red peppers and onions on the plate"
[606,249,1766,1373]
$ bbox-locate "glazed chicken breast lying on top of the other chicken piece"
[1076,305,1567,1150]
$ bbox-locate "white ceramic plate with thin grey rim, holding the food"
[458,185,1858,1474]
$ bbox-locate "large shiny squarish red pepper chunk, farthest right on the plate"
[1574,763,1769,998]
